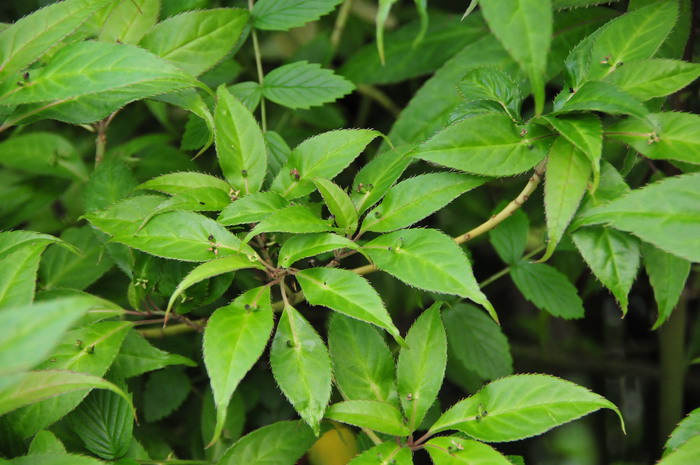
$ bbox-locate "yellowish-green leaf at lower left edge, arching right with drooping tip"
[0,370,131,417]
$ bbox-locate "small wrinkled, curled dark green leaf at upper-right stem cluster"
[459,68,523,121]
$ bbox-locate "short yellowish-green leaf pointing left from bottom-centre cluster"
[326,400,411,436]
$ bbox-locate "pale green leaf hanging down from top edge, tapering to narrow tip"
[481,0,554,115]
